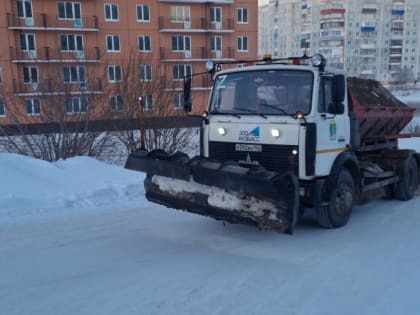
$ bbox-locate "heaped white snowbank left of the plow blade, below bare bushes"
[0,153,144,220]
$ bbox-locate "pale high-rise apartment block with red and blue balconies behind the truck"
[259,0,420,82]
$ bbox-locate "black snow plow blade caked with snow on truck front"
[125,150,299,234]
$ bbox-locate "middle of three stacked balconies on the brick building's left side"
[9,47,101,63]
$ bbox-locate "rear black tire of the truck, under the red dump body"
[394,155,419,200]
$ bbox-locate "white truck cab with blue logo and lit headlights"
[202,57,350,180]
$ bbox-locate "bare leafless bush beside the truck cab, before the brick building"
[105,48,198,153]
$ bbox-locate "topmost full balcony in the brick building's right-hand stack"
[159,16,235,33]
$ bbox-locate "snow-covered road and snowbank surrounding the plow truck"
[0,139,420,315]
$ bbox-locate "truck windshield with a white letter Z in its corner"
[209,69,313,115]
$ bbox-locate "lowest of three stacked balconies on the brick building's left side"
[13,78,103,96]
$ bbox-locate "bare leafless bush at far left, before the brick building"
[0,65,109,161]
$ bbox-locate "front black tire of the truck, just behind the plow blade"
[316,169,356,229]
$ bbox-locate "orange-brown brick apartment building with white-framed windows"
[0,0,258,124]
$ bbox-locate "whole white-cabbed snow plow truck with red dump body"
[125,54,420,233]
